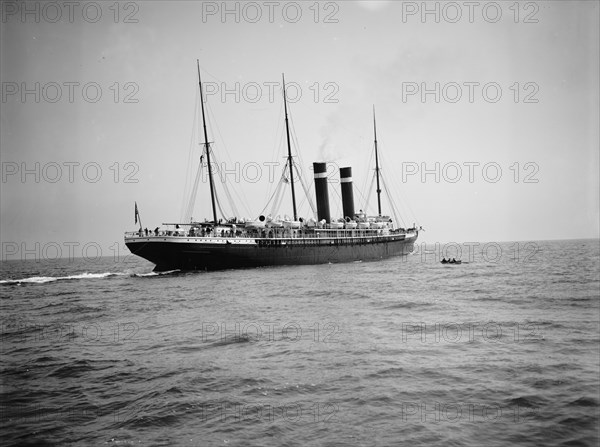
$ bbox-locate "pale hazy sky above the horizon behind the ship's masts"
[0,1,600,259]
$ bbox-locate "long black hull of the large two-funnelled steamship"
[125,232,418,271]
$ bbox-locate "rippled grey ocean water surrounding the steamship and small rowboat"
[0,240,600,446]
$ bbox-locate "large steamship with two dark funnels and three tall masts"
[125,63,421,271]
